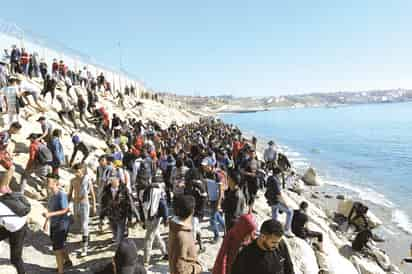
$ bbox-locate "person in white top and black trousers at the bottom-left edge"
[0,193,27,274]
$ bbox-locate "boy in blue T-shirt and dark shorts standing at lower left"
[43,173,73,274]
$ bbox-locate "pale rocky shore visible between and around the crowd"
[0,77,408,274]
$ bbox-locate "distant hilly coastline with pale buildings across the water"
[179,89,412,112]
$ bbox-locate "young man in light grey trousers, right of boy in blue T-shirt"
[69,163,96,257]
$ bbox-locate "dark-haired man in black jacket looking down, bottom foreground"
[231,219,294,274]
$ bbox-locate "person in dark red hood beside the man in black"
[212,214,256,274]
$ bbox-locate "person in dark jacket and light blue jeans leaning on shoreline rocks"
[265,168,293,236]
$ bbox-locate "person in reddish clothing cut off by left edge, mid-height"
[0,122,22,191]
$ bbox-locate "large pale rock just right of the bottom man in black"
[285,237,319,274]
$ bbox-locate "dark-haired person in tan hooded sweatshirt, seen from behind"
[168,195,202,274]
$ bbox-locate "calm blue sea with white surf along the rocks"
[221,103,412,233]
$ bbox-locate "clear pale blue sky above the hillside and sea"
[0,0,412,96]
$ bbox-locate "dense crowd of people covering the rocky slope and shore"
[0,42,408,274]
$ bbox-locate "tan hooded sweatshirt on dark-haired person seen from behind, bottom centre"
[168,217,202,274]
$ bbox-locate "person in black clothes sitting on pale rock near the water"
[292,201,323,251]
